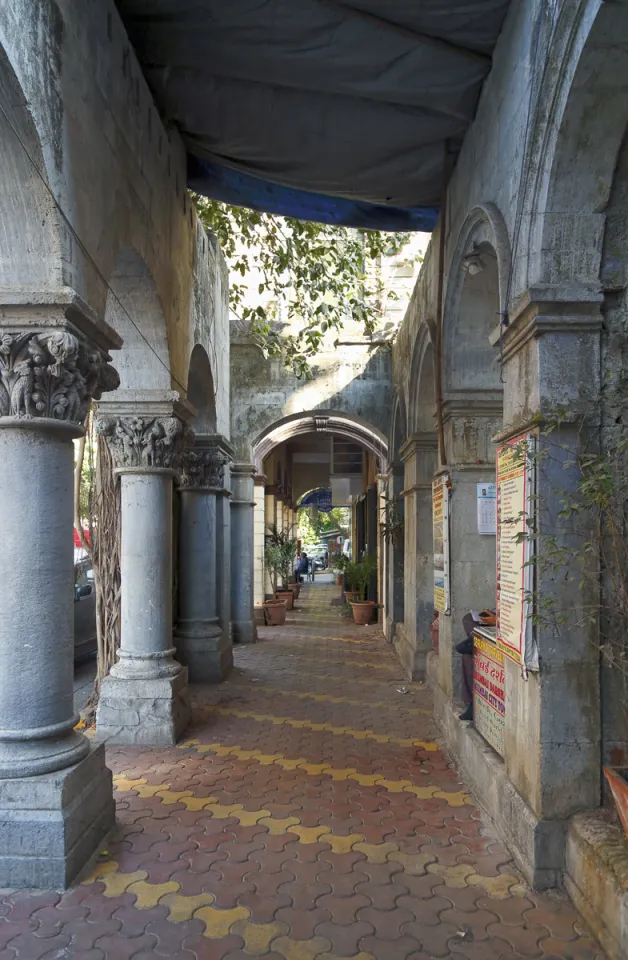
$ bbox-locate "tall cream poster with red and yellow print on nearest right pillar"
[496,434,536,666]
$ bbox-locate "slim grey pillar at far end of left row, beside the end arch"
[231,463,257,643]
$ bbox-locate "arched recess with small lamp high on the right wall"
[443,203,511,398]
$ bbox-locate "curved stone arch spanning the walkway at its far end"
[253,410,388,473]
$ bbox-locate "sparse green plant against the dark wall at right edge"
[520,404,628,678]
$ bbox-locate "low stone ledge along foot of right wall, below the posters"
[427,653,567,890]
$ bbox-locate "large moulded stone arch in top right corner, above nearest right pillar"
[528,0,628,293]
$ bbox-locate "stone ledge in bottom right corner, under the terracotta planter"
[565,810,628,960]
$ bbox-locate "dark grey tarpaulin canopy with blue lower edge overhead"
[118,0,509,229]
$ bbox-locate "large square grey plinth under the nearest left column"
[0,744,115,889]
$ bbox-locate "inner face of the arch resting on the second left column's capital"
[105,247,172,390]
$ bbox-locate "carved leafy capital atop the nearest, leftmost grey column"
[0,328,120,426]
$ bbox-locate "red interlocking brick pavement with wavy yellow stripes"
[0,586,603,960]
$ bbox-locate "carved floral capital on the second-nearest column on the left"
[96,416,191,469]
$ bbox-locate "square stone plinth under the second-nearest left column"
[96,667,191,747]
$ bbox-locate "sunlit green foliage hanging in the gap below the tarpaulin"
[194,196,409,377]
